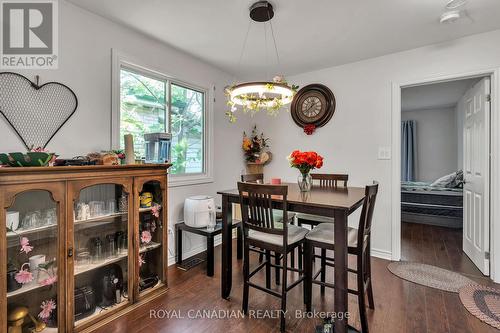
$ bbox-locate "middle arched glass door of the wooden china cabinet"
[70,184,131,327]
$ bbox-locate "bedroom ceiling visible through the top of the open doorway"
[401,78,480,112]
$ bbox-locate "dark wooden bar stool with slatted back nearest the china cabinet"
[238,182,308,332]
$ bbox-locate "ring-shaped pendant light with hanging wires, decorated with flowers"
[226,1,298,122]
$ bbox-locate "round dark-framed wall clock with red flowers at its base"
[290,83,336,135]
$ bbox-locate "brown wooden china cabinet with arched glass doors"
[0,164,170,333]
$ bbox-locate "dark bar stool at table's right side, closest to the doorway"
[304,183,378,333]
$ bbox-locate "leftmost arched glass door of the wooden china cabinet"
[5,186,64,333]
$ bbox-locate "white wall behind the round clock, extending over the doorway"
[255,30,500,257]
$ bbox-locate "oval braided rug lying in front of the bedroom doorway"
[387,261,476,293]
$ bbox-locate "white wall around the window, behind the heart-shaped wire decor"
[0,1,248,262]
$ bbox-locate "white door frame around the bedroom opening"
[391,68,500,283]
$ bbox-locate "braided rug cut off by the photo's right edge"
[459,285,500,329]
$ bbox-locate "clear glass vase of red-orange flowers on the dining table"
[288,150,323,192]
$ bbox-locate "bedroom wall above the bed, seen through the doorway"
[401,108,458,182]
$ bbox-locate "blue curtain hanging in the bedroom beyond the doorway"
[401,120,417,181]
